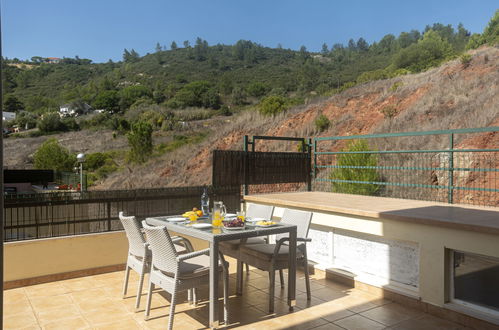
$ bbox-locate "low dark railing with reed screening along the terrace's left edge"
[4,187,241,241]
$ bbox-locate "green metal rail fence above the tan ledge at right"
[312,127,499,206]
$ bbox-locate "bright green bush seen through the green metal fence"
[330,140,381,195]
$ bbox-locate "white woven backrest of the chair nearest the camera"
[142,220,178,275]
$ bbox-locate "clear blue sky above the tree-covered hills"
[0,0,499,62]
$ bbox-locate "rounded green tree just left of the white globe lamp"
[33,138,76,171]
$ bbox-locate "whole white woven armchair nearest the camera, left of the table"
[142,221,229,330]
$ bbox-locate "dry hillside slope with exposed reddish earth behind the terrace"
[86,47,499,193]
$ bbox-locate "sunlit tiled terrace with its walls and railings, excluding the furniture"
[3,128,499,329]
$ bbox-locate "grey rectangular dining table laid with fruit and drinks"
[145,216,297,328]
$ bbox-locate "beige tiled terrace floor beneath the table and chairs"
[4,262,472,330]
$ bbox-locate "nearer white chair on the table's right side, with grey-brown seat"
[239,209,312,313]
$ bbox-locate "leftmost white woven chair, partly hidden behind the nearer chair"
[119,212,193,309]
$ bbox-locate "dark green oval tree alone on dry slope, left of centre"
[127,121,153,163]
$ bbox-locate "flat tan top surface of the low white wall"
[244,191,499,234]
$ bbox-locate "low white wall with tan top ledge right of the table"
[245,192,499,307]
